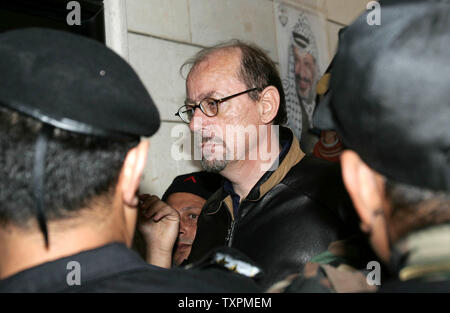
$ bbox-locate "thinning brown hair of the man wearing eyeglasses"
[181,39,287,125]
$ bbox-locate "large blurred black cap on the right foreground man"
[315,2,450,191]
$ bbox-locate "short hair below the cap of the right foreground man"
[385,179,450,241]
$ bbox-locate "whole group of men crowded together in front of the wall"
[0,1,450,292]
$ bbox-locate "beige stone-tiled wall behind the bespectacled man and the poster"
[126,0,369,196]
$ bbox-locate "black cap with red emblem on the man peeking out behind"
[161,171,222,201]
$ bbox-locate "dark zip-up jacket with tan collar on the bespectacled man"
[188,127,360,287]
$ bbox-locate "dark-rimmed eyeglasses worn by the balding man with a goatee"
[175,88,260,124]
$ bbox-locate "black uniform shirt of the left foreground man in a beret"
[0,243,259,293]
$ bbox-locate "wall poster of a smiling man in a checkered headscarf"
[275,3,329,153]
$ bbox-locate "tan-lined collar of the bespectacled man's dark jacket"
[205,126,305,219]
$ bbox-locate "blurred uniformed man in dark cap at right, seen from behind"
[286,1,450,293]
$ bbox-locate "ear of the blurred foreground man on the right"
[341,150,384,227]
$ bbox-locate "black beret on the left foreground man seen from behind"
[0,28,160,137]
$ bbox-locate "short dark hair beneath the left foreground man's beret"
[0,108,138,228]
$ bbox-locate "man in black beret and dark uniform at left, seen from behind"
[0,28,256,292]
